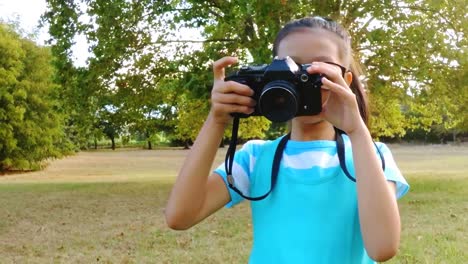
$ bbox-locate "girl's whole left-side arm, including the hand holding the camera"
[165,57,255,229]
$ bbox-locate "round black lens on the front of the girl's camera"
[258,81,298,122]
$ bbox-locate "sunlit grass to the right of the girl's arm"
[384,145,468,263]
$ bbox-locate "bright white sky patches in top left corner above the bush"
[0,0,88,66]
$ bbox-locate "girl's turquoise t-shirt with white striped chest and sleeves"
[215,136,409,264]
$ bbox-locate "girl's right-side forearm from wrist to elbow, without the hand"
[348,125,401,261]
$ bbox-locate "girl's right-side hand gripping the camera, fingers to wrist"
[307,62,365,135]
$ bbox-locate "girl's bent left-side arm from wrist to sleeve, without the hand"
[165,115,230,230]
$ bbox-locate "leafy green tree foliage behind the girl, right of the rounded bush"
[44,0,468,148]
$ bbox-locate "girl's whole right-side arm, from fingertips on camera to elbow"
[308,62,401,261]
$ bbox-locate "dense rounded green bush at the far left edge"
[0,24,63,170]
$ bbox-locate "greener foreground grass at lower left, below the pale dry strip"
[0,182,252,263]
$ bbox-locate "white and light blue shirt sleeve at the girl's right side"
[376,142,409,199]
